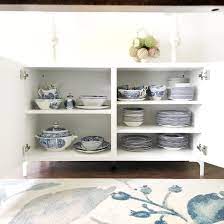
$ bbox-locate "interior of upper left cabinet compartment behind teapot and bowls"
[25,68,111,110]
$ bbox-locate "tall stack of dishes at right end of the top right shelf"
[167,78,195,100]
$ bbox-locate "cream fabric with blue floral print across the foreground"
[0,179,224,224]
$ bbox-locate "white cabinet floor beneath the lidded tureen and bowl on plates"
[25,149,113,162]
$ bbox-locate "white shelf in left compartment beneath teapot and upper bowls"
[26,109,111,114]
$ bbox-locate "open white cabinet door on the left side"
[0,58,25,178]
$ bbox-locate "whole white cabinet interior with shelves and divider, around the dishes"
[21,65,206,164]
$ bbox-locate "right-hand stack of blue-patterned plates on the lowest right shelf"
[158,134,190,150]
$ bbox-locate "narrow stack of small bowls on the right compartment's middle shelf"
[123,108,144,127]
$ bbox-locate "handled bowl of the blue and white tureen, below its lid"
[35,135,77,152]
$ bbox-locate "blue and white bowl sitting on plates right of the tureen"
[81,136,104,150]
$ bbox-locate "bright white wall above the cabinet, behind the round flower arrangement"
[0,12,224,64]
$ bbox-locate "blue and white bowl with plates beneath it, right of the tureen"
[74,136,110,153]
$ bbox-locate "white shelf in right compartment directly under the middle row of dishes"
[117,125,201,134]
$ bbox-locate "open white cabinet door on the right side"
[197,62,224,167]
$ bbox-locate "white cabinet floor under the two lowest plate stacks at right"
[117,148,194,161]
